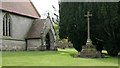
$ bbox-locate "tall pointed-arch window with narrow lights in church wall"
[3,13,11,36]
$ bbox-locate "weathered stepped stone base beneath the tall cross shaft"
[79,45,101,58]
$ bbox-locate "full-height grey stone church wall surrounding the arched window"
[0,11,34,50]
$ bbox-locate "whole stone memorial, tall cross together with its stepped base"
[79,11,101,58]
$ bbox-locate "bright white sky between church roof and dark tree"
[31,0,59,18]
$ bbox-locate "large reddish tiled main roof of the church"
[0,0,40,18]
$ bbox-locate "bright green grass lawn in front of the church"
[2,49,118,66]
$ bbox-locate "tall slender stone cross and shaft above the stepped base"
[85,11,92,45]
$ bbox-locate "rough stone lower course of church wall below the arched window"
[2,39,26,51]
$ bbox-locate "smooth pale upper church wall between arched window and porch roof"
[2,12,34,39]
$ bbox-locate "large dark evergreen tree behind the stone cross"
[59,2,120,56]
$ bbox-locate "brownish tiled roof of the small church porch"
[26,18,51,39]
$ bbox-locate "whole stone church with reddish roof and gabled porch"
[0,0,56,51]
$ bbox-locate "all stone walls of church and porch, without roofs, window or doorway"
[0,11,56,51]
